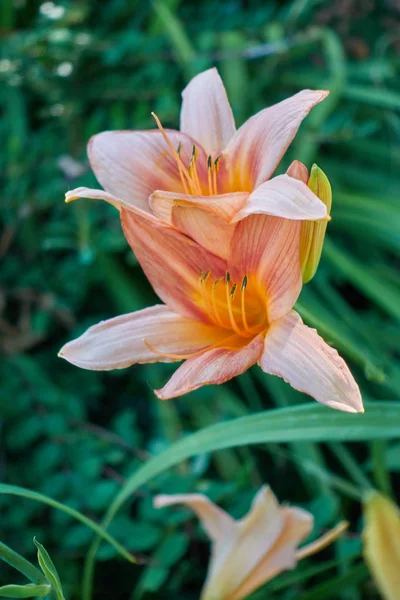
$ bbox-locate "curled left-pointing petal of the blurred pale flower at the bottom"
[154,494,237,545]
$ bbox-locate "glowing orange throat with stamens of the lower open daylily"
[199,271,268,338]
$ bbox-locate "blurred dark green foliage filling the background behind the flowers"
[0,0,400,600]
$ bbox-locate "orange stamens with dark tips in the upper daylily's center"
[151,112,222,196]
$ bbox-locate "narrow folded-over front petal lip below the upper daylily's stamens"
[149,190,249,224]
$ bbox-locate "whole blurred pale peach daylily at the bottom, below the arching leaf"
[154,486,347,600]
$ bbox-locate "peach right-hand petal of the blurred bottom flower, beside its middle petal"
[233,507,314,600]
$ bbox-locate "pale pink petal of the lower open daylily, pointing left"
[59,305,226,371]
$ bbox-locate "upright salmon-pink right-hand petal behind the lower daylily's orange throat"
[228,215,302,323]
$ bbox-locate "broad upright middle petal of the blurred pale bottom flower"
[201,486,284,600]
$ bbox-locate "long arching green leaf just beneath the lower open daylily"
[83,401,400,600]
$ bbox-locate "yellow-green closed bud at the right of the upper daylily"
[300,165,332,283]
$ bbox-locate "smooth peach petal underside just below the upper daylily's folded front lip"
[172,206,235,260]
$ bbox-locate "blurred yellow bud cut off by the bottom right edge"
[363,491,400,600]
